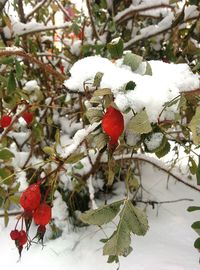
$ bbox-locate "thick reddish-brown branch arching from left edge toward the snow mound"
[0,50,67,83]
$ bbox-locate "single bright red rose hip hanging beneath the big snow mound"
[102,106,124,145]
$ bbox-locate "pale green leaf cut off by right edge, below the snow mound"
[188,106,200,145]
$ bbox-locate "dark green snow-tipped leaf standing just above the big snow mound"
[107,38,124,59]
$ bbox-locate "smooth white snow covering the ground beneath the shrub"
[0,161,200,270]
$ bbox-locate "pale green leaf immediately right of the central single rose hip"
[127,110,152,134]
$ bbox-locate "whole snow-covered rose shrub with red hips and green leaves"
[0,0,200,263]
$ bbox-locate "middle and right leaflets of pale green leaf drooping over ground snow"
[103,200,148,256]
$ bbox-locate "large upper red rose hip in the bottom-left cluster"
[20,184,41,211]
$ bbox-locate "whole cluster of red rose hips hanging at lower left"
[10,184,51,255]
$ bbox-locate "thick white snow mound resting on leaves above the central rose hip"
[64,56,199,122]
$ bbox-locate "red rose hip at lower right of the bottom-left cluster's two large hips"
[33,203,51,226]
